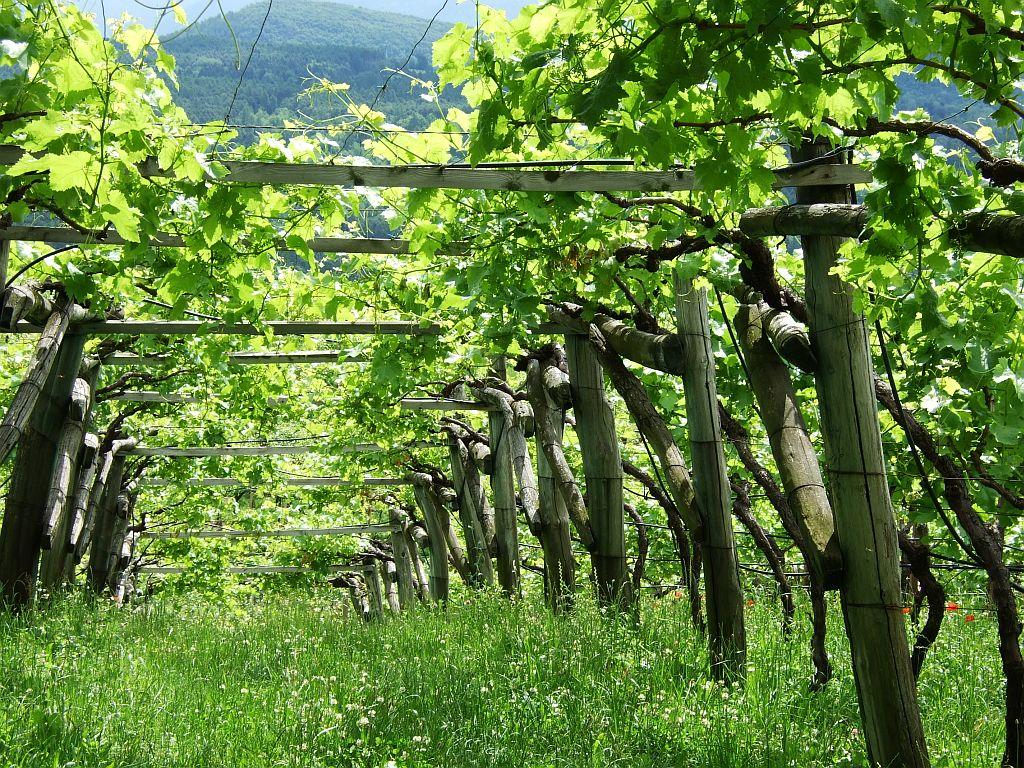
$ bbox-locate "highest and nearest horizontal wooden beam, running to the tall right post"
[0,145,871,193]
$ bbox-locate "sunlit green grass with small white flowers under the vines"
[0,594,1000,768]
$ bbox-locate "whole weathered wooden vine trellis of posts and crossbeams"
[0,144,1024,767]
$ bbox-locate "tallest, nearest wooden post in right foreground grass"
[793,142,929,768]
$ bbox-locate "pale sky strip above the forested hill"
[75,0,528,31]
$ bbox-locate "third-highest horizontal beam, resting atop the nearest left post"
[3,321,440,336]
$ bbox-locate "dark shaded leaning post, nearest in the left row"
[0,327,85,610]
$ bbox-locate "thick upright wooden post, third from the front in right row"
[565,334,634,609]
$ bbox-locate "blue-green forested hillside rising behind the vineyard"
[167,2,451,136]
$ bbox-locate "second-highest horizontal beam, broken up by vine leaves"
[0,226,417,256]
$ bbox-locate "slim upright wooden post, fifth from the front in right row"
[487,412,519,597]
